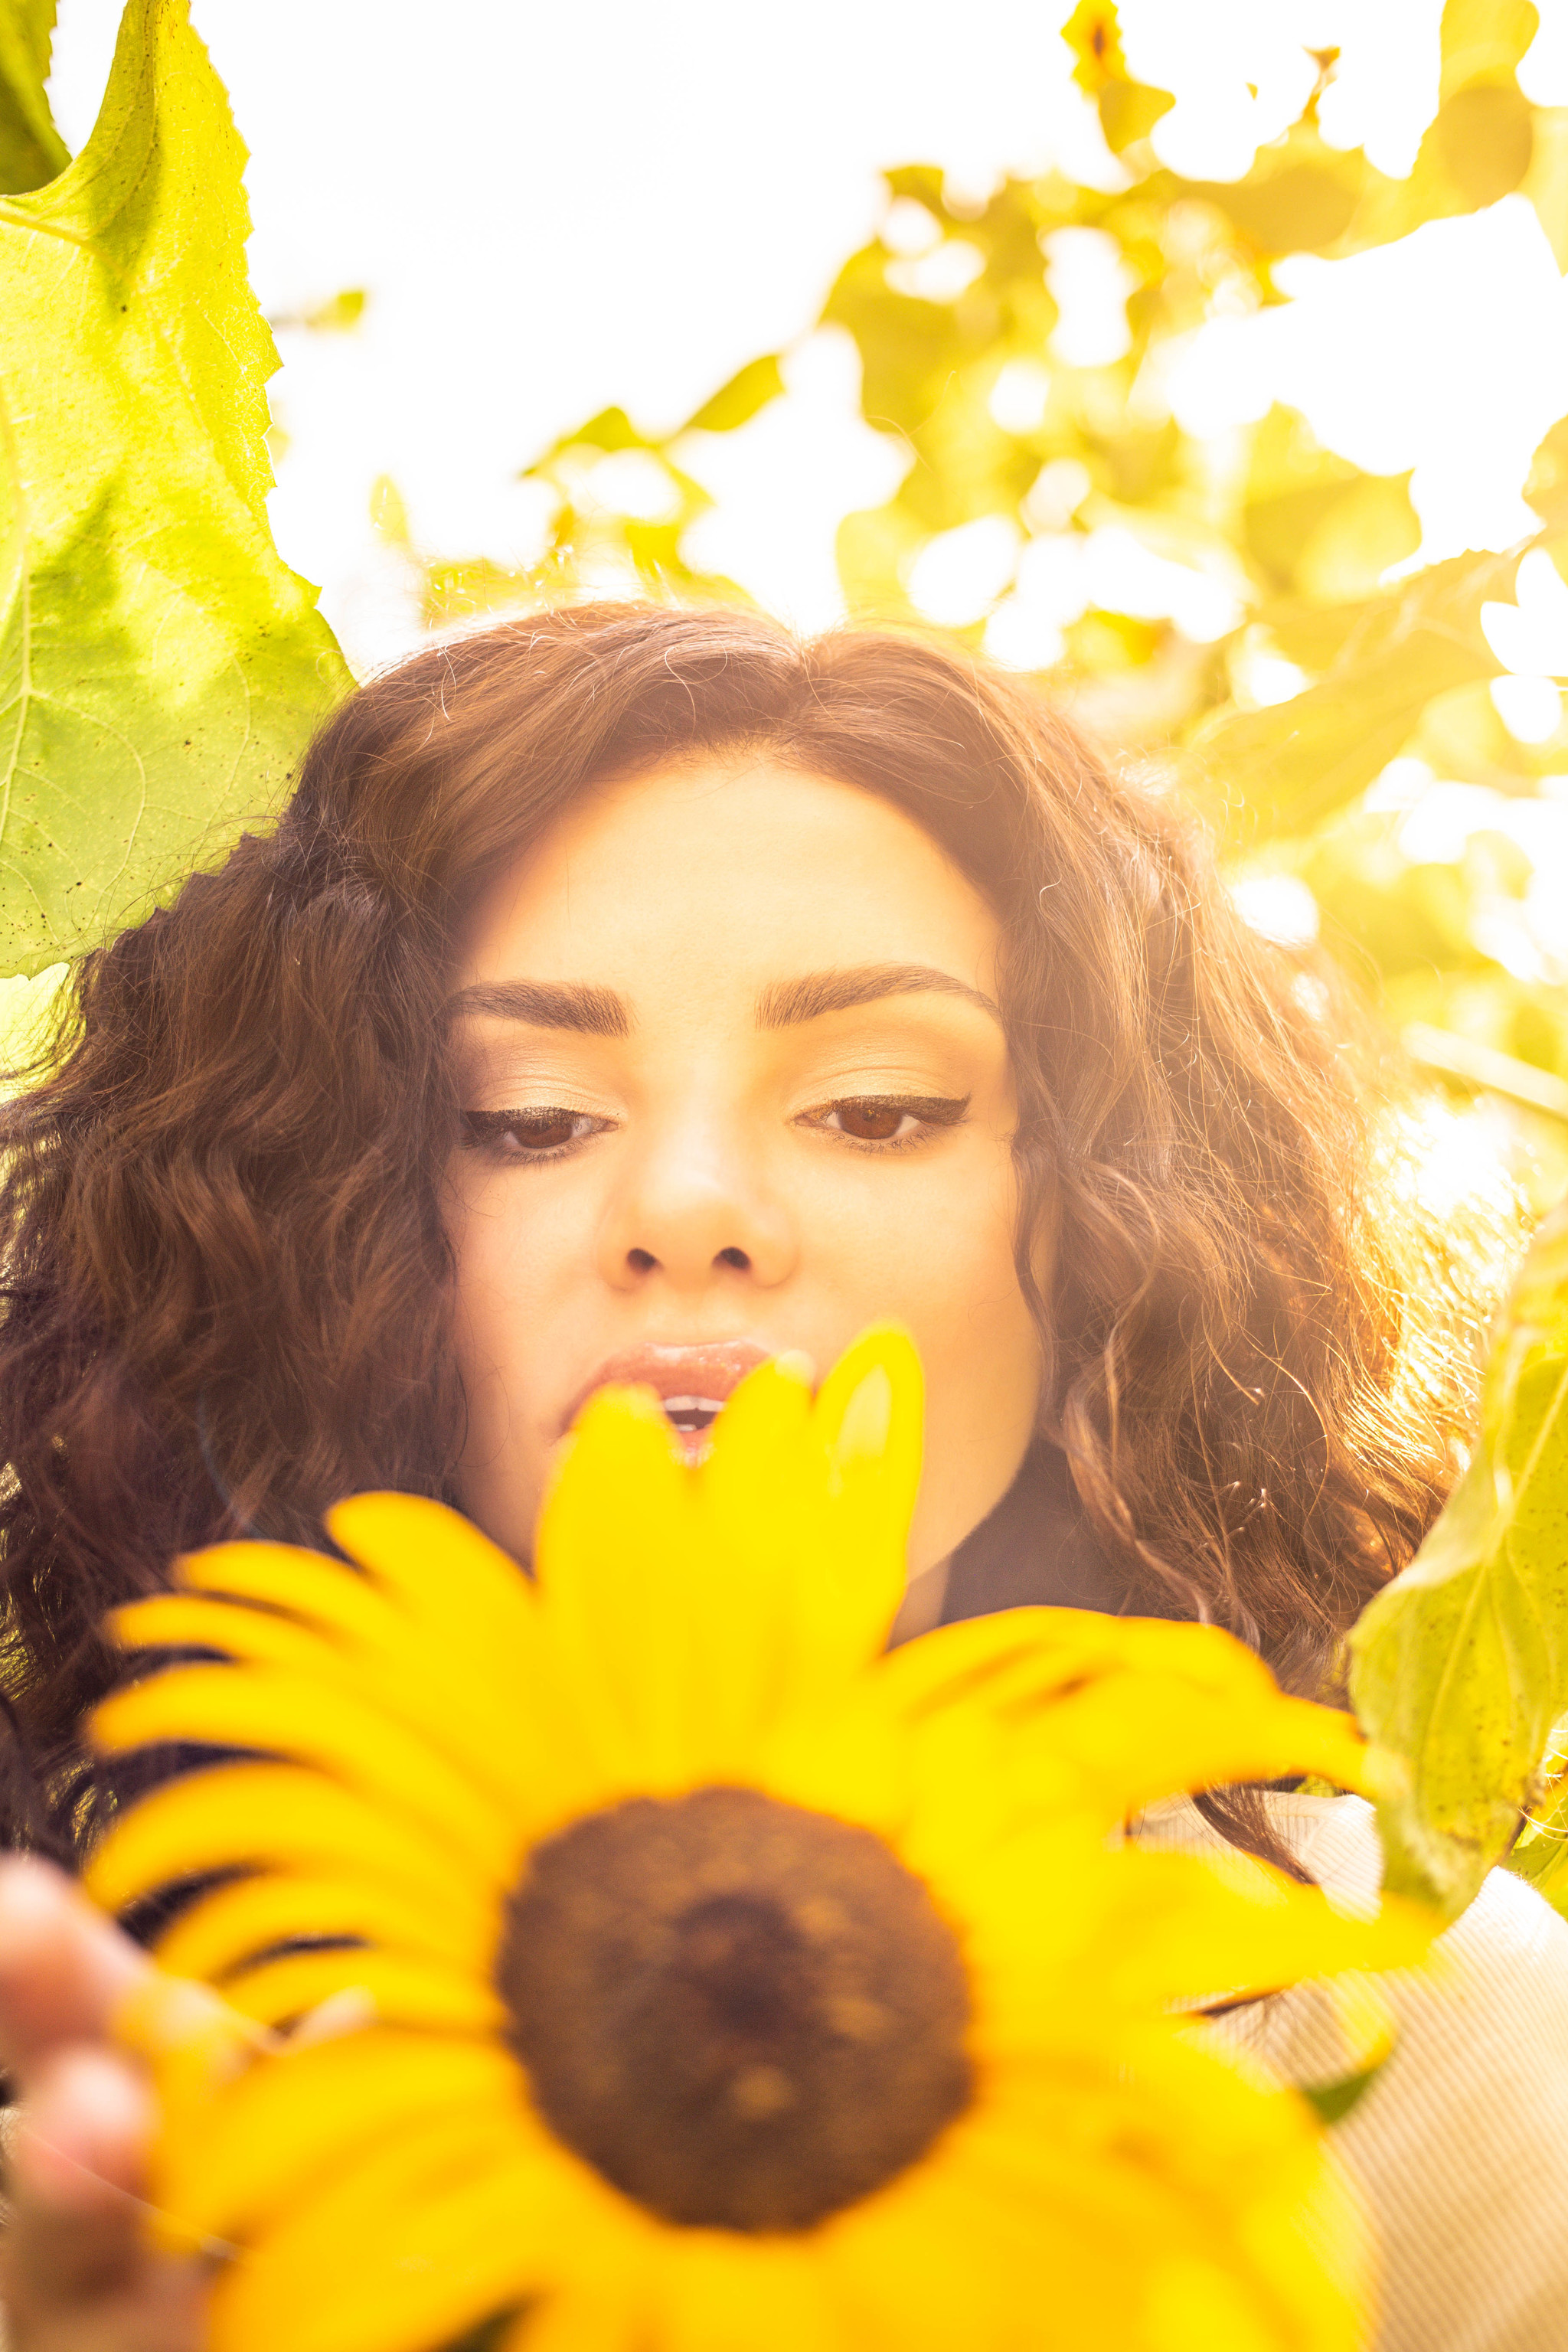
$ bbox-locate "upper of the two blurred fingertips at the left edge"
[0,1856,148,2089]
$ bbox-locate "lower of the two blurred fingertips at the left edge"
[5,2049,153,2310]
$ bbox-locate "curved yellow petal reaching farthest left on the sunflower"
[85,1764,498,1955]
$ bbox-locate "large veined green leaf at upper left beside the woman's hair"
[0,0,350,972]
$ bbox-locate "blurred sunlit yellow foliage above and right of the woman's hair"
[404,0,1568,1183]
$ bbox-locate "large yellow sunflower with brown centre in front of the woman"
[90,1331,1423,2352]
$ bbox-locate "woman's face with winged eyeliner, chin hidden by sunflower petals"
[452,755,1039,1576]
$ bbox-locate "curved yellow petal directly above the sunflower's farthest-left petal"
[87,1665,520,1884]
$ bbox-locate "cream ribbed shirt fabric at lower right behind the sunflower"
[1138,1795,1568,2352]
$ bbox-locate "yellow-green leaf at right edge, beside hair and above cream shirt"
[1349,1204,1568,1917]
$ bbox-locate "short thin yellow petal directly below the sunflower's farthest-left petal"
[153,1870,472,1983]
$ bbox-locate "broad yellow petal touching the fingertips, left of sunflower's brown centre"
[155,2027,518,2244]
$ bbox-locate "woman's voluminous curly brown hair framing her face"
[0,605,1469,1854]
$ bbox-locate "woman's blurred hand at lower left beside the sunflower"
[0,1858,204,2352]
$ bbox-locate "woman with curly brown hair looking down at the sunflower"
[0,607,1568,2352]
